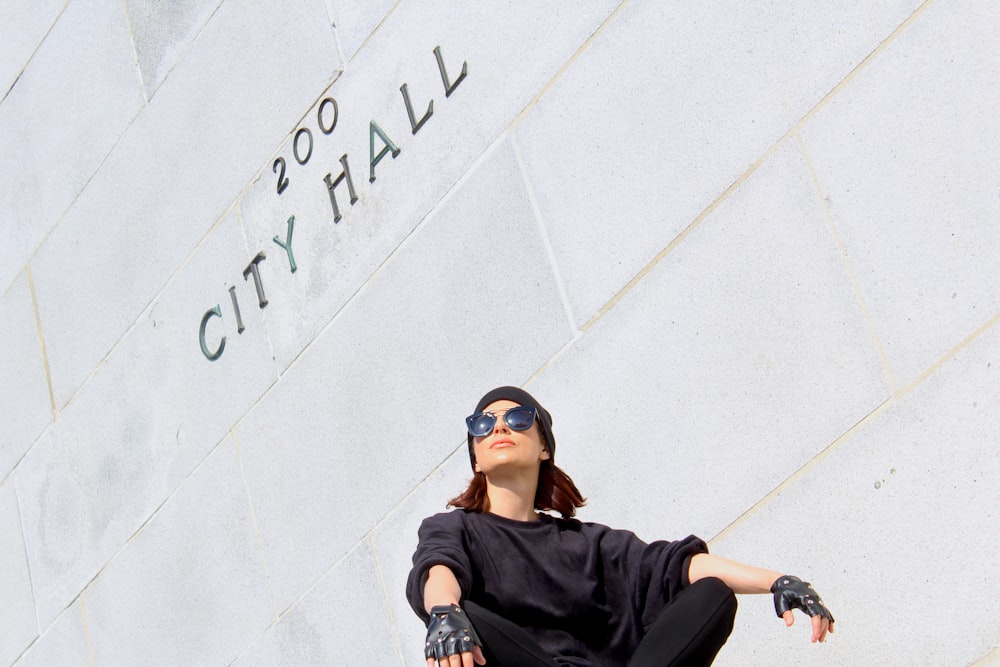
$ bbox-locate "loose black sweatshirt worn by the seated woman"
[406,510,708,665]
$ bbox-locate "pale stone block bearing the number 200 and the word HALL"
[240,2,612,368]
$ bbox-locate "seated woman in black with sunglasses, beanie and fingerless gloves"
[407,387,833,667]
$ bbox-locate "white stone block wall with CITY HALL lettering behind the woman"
[0,0,1000,667]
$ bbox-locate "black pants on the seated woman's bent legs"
[462,578,736,667]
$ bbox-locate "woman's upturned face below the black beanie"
[472,400,549,477]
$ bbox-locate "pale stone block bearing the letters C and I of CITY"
[14,215,277,624]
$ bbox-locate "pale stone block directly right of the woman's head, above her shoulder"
[529,140,891,540]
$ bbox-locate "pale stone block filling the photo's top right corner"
[803,0,1000,386]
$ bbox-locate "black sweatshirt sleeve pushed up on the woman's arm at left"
[406,510,472,623]
